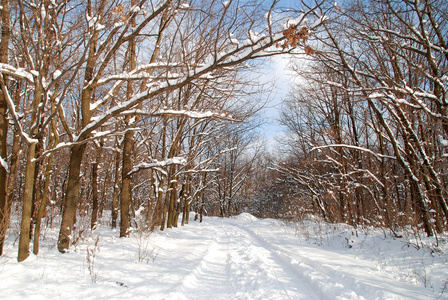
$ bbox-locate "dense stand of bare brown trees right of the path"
[284,1,447,235]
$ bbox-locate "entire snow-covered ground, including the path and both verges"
[0,214,448,300]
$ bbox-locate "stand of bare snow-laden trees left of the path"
[0,0,328,261]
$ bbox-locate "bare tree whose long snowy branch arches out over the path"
[53,2,322,252]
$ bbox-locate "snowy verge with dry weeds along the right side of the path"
[290,216,448,299]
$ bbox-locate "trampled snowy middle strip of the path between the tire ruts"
[176,221,319,300]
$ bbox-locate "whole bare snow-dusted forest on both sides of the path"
[0,0,448,262]
